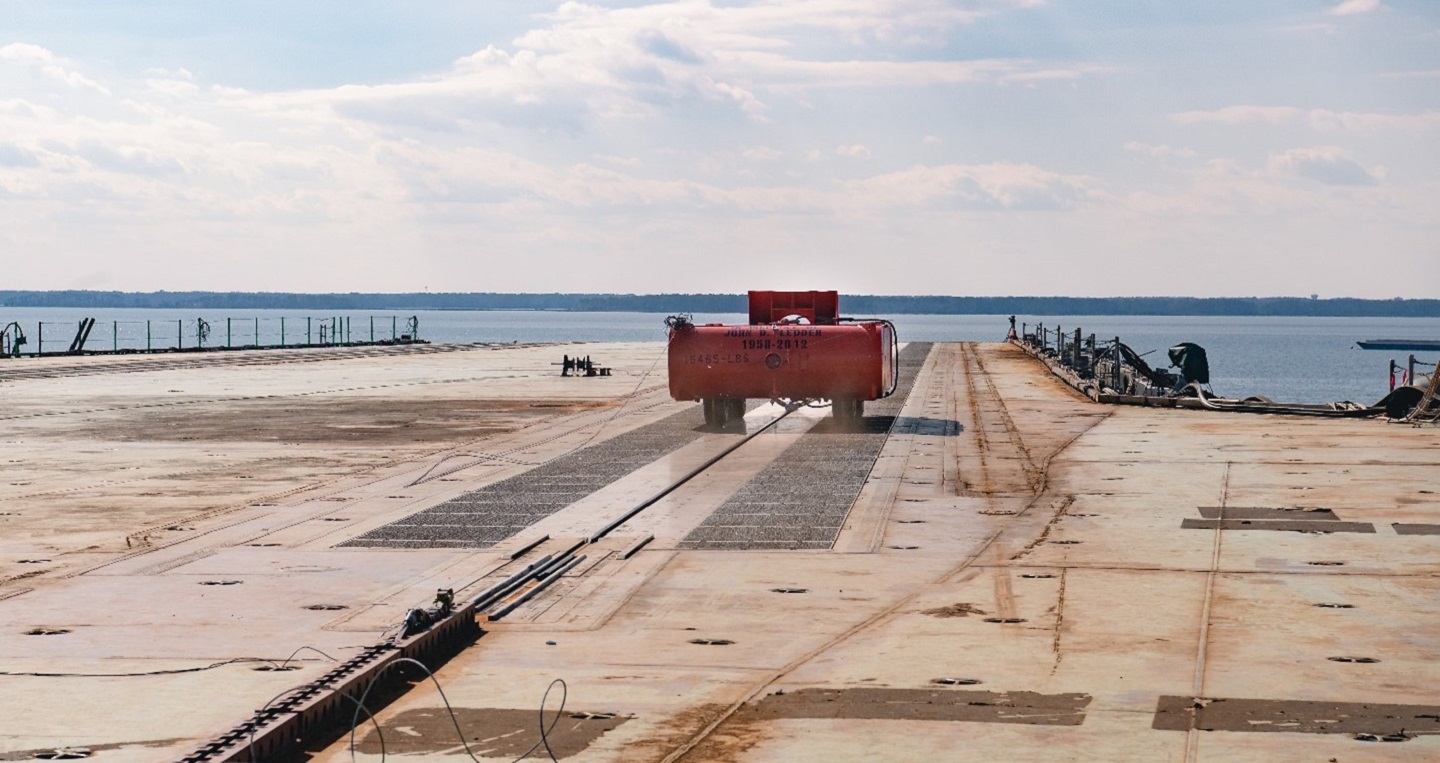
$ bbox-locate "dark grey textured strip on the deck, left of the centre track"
[341,406,704,548]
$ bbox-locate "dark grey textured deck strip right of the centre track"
[680,343,930,550]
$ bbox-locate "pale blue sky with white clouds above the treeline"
[0,0,1440,299]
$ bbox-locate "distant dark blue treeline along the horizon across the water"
[0,291,1440,320]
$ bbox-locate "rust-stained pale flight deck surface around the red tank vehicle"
[0,344,1440,762]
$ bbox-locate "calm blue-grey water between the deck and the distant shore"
[0,308,1440,403]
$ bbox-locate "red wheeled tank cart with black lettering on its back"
[667,291,899,428]
